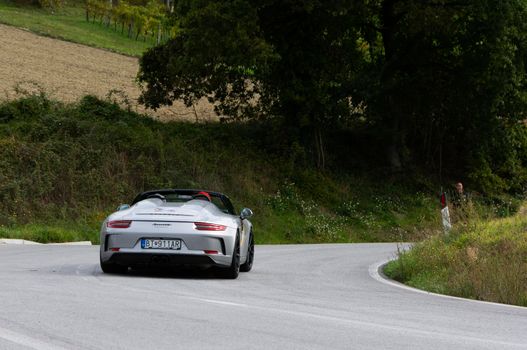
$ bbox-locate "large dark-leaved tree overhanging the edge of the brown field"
[139,0,361,167]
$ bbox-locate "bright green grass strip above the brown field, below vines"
[0,0,154,56]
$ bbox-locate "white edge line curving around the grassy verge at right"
[368,258,527,311]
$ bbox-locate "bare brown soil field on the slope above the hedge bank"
[0,24,218,121]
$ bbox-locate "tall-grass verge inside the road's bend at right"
[384,211,527,306]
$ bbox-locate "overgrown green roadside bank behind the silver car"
[0,95,448,243]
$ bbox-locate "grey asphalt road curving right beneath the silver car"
[0,244,527,350]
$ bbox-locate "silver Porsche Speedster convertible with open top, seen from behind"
[100,189,254,278]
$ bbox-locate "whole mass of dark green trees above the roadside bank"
[139,0,527,192]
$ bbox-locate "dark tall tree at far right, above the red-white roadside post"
[356,0,527,173]
